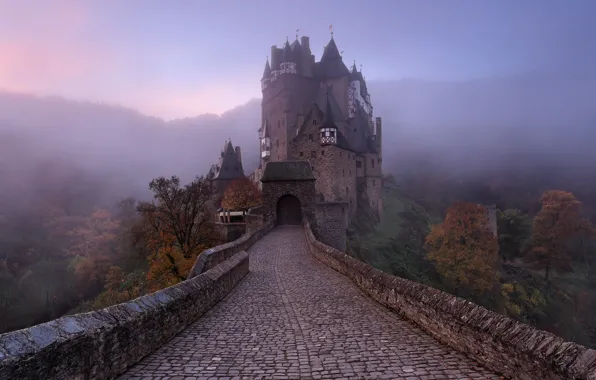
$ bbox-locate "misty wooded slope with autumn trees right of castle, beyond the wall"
[350,160,596,347]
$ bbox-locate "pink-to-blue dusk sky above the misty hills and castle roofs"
[0,0,596,119]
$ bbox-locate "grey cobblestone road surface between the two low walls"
[121,226,498,379]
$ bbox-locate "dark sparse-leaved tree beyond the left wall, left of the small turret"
[137,176,214,259]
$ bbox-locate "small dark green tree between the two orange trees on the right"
[497,209,532,262]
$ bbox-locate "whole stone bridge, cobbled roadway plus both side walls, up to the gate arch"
[0,162,596,380]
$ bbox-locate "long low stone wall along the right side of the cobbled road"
[305,221,596,380]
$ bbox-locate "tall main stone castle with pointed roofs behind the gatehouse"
[251,35,383,223]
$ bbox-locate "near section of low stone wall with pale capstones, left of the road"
[0,252,248,380]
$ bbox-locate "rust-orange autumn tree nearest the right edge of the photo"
[525,190,593,282]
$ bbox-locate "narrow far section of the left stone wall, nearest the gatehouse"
[188,222,274,278]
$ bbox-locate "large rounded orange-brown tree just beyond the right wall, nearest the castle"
[425,202,499,294]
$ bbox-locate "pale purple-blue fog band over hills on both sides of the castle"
[0,69,596,211]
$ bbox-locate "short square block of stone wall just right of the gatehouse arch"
[313,202,350,251]
